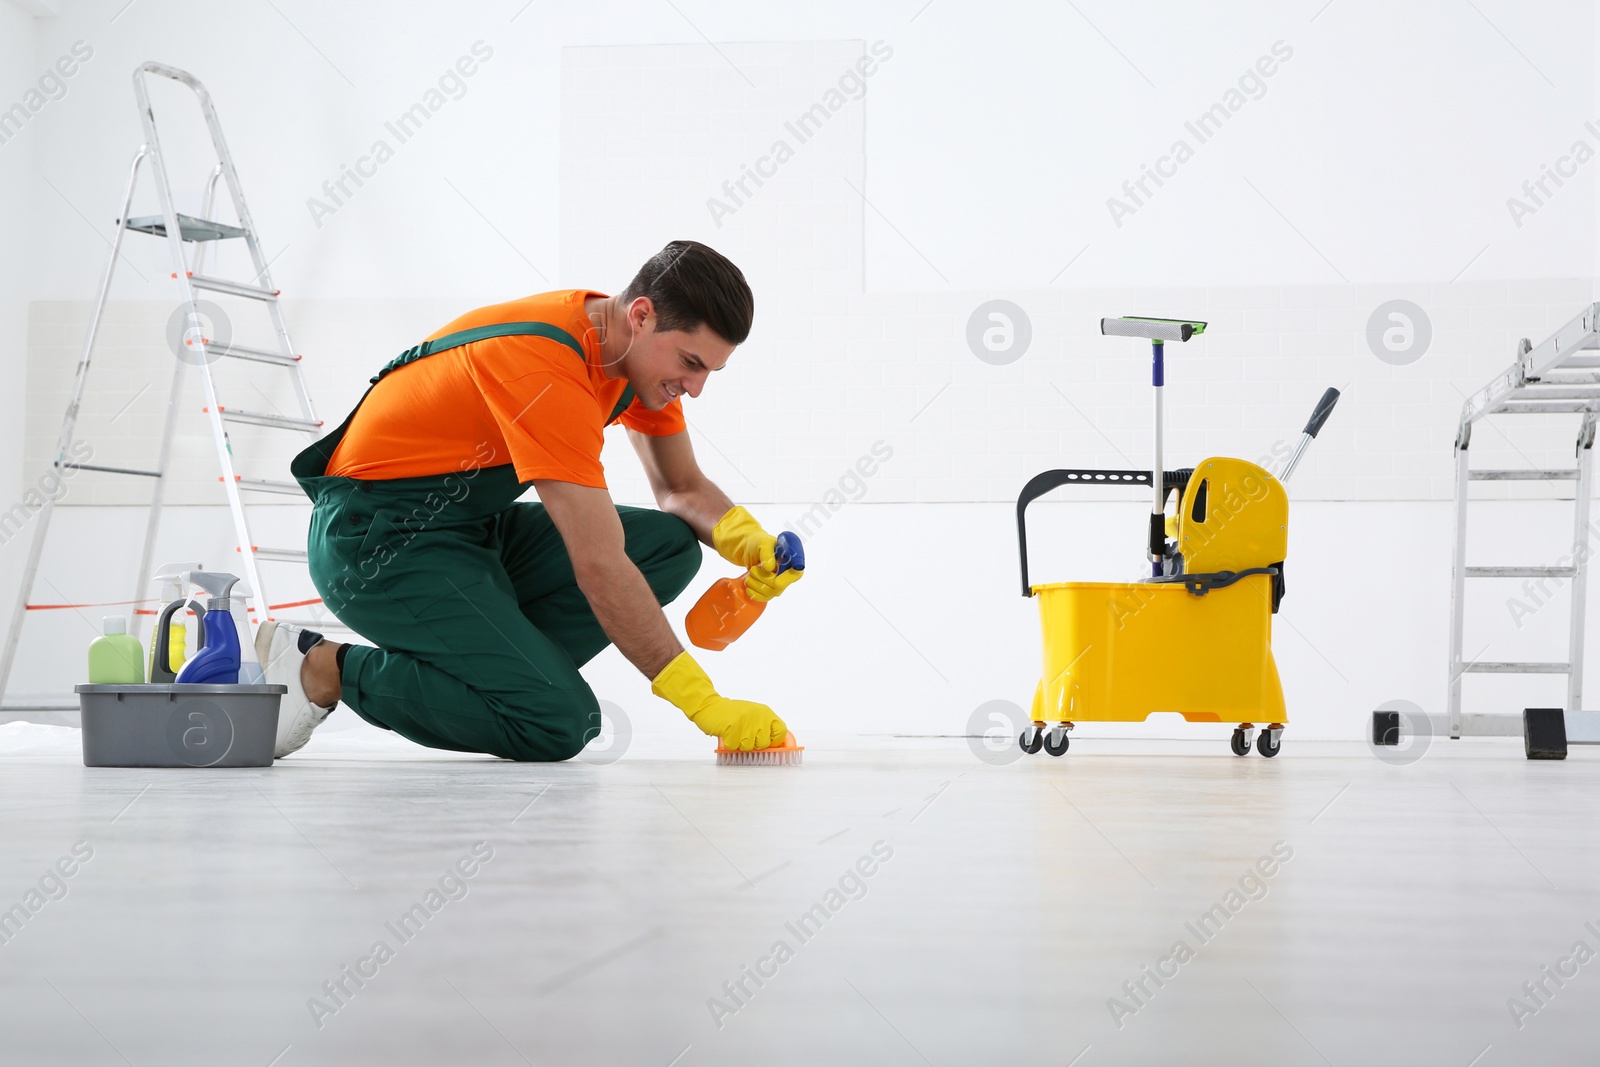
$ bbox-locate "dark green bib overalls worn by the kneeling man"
[290,322,701,760]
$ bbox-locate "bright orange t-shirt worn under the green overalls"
[328,290,685,490]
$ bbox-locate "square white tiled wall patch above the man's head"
[560,40,880,294]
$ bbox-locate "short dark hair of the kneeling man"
[621,242,755,344]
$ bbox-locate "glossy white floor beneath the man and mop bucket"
[0,723,1600,1067]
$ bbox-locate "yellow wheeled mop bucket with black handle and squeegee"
[1018,318,1339,757]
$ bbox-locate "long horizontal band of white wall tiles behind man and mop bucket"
[27,277,1589,504]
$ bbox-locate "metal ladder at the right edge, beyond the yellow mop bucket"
[1445,304,1600,742]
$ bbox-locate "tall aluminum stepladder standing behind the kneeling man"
[0,62,338,710]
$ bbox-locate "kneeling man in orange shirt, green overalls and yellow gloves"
[256,242,805,760]
